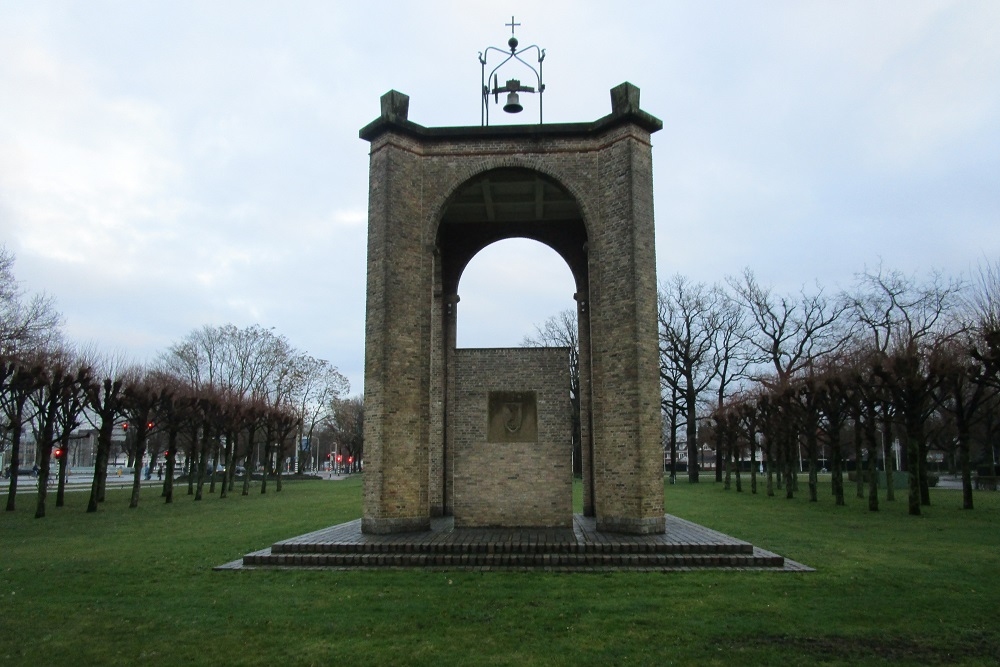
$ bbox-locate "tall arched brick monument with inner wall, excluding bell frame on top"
[360,83,665,535]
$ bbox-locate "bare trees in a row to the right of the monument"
[660,263,1000,514]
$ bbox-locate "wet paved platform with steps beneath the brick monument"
[216,514,812,572]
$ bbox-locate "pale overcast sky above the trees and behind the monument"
[0,0,1000,392]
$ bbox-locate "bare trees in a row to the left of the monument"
[0,248,363,517]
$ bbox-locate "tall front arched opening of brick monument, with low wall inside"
[430,168,589,527]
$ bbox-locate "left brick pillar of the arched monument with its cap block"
[362,91,433,533]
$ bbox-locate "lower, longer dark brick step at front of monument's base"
[243,549,784,569]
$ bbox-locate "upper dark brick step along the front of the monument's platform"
[271,540,753,556]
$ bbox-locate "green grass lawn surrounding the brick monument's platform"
[0,478,1000,667]
